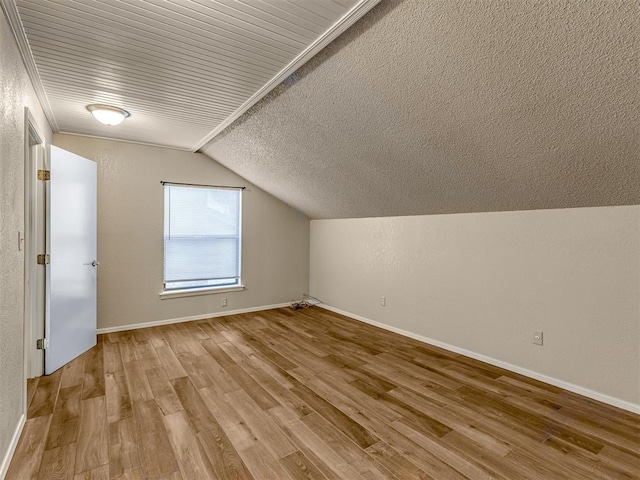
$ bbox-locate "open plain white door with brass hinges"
[45,146,97,375]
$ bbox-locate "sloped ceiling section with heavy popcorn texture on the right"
[203,0,640,218]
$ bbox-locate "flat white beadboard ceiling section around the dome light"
[7,0,379,150]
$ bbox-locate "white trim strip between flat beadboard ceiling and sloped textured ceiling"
[192,0,380,152]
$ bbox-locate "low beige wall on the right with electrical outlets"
[310,206,640,411]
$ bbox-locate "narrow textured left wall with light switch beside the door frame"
[0,6,51,472]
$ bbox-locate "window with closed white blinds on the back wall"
[164,183,242,292]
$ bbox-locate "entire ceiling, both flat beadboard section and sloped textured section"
[0,0,640,218]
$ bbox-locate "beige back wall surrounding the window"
[54,134,309,328]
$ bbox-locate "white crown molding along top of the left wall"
[0,0,58,133]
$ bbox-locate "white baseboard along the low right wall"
[318,304,640,414]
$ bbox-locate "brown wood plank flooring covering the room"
[7,308,640,480]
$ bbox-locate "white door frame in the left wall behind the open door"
[19,107,46,394]
